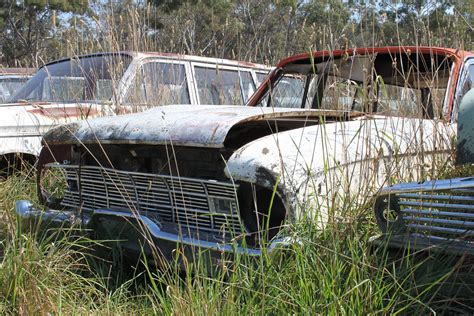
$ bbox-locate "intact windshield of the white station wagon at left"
[9,54,131,102]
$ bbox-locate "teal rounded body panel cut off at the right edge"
[456,89,474,165]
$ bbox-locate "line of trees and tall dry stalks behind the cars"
[0,0,474,67]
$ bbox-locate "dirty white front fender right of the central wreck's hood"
[226,117,454,221]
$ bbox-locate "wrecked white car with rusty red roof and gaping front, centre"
[16,47,472,260]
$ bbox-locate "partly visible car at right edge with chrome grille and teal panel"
[370,87,474,255]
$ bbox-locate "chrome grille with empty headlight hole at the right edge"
[375,178,474,242]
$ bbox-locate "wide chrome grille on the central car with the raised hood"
[52,164,243,235]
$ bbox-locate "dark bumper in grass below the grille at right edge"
[369,233,474,256]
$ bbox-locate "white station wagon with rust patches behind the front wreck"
[0,52,270,173]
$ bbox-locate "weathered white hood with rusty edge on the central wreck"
[44,105,343,148]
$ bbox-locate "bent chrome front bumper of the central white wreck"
[15,200,294,261]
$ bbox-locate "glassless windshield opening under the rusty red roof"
[258,54,452,118]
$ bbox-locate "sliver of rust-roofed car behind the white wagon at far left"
[0,68,34,103]
